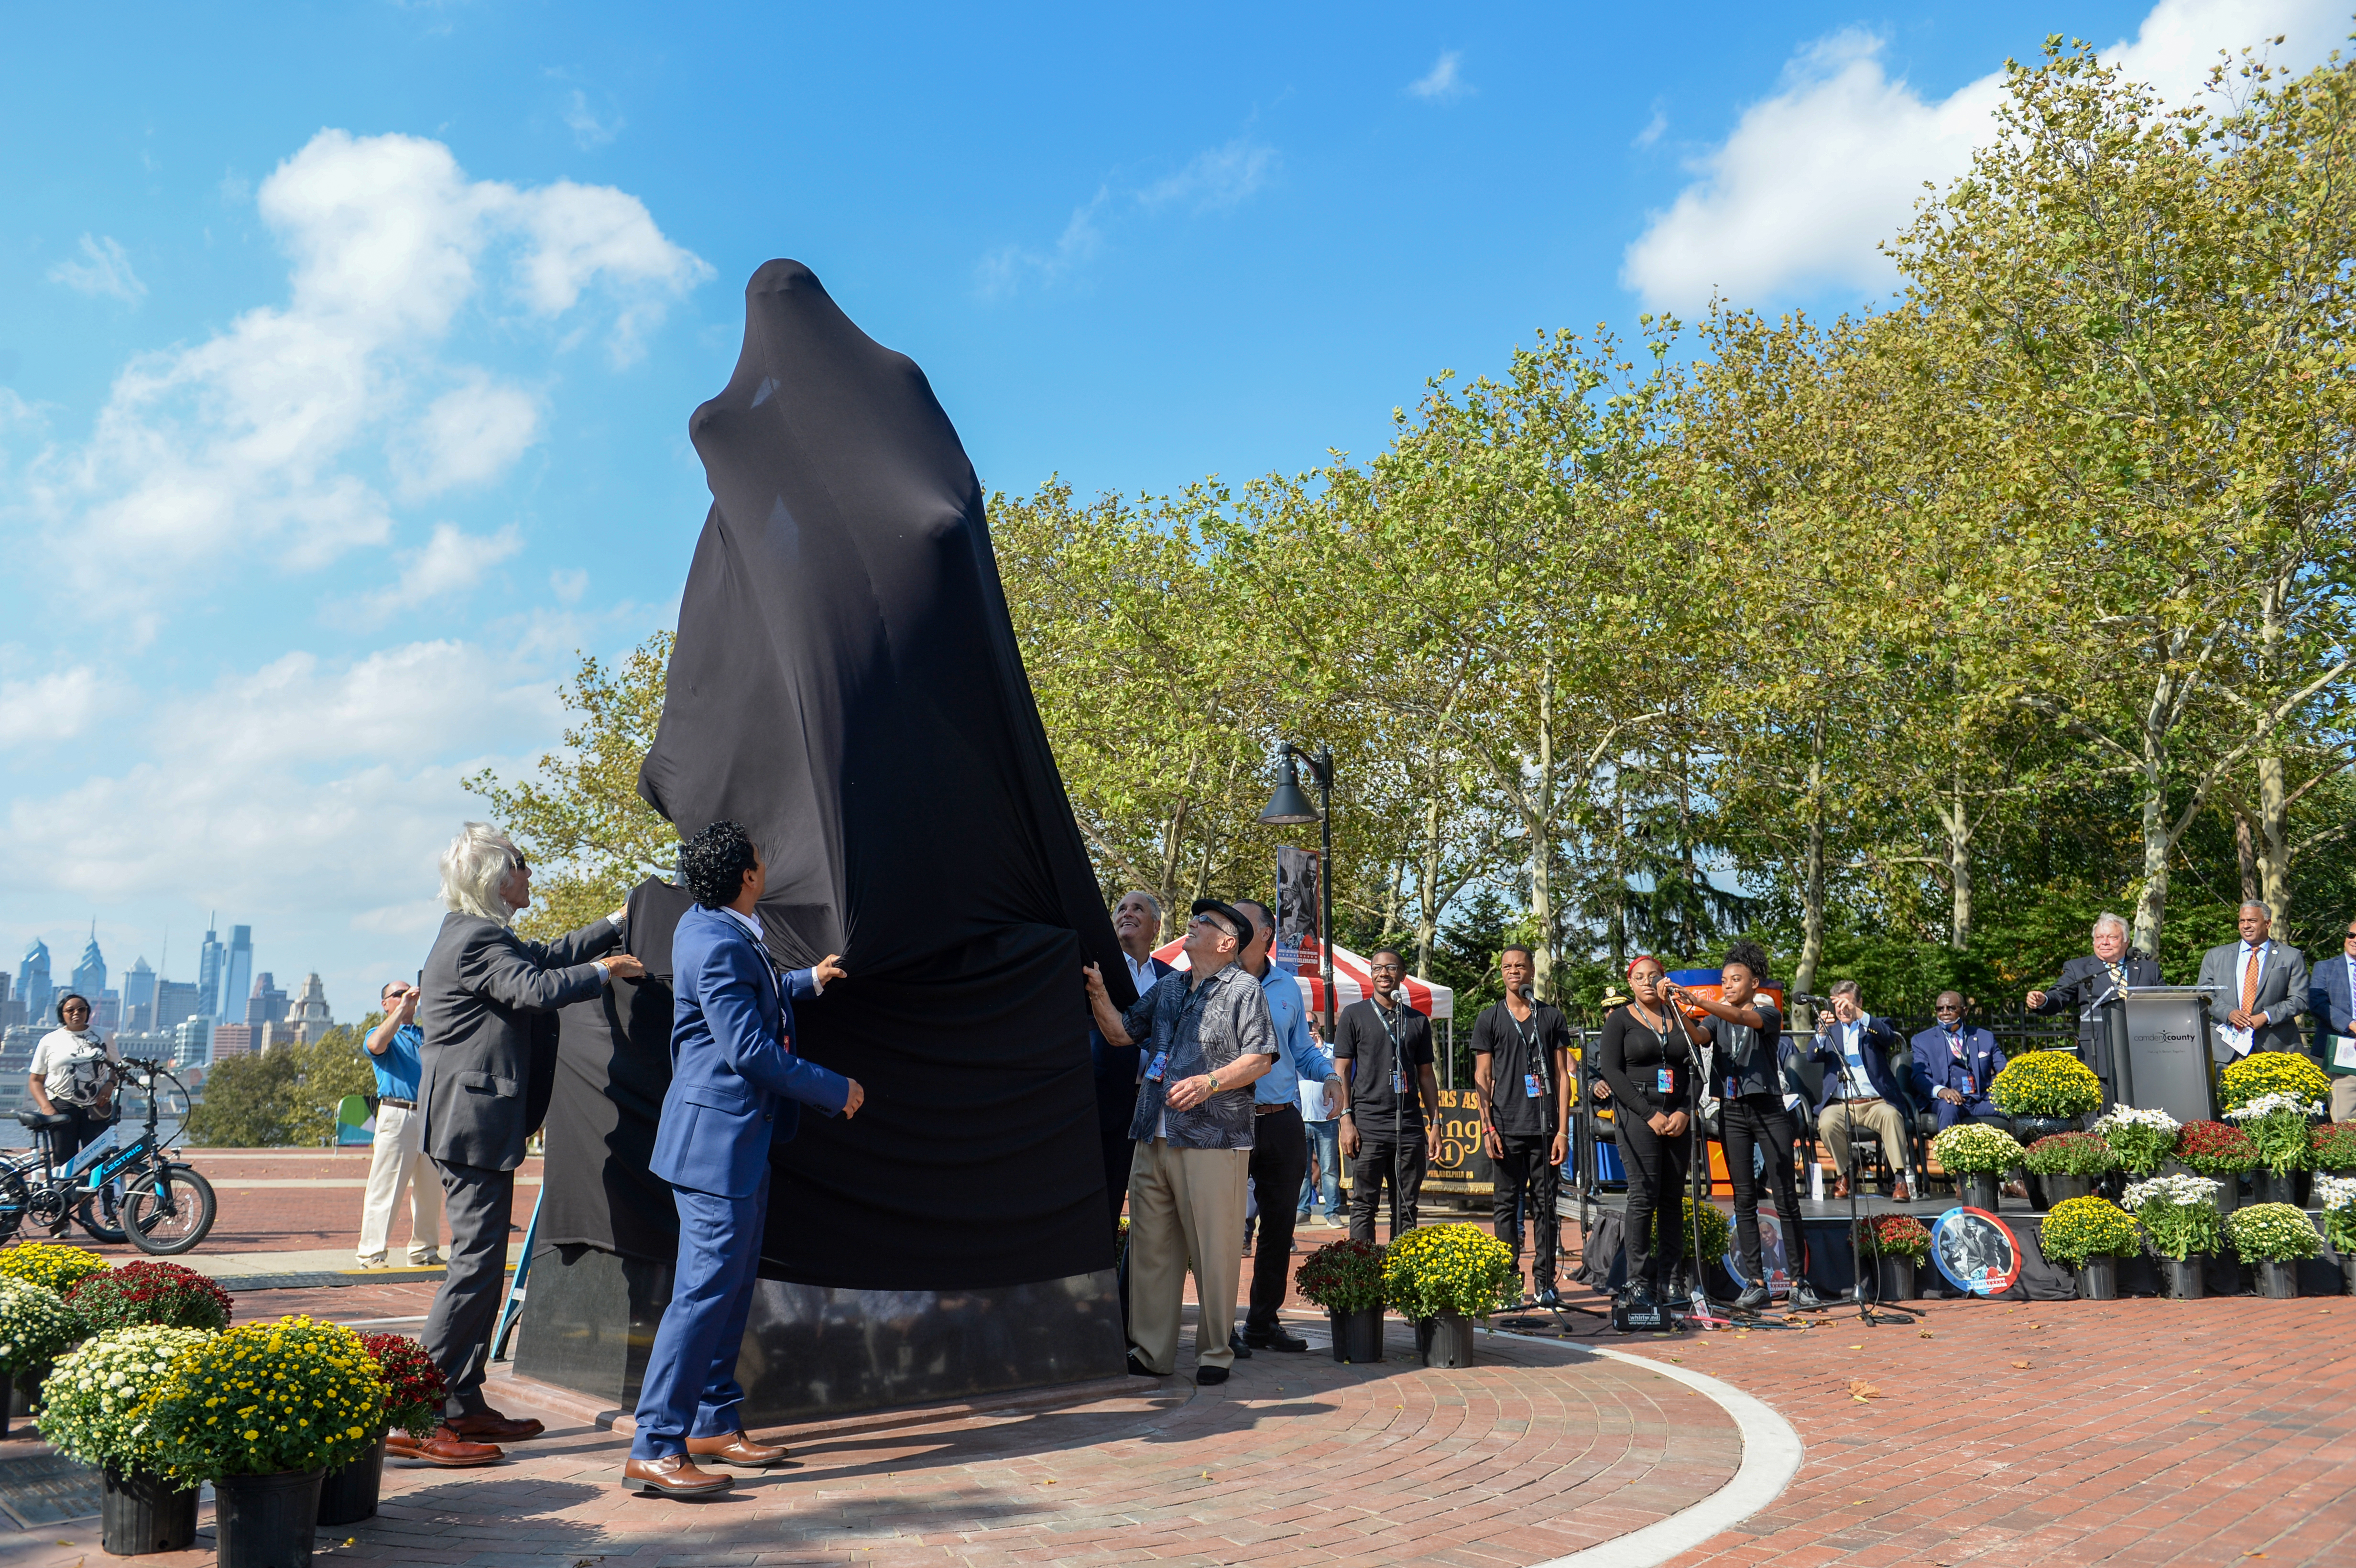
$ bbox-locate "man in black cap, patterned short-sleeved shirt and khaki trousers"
[1084,899,1277,1387]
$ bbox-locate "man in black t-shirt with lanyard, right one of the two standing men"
[1472,944,1571,1307]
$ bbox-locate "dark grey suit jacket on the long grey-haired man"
[417,911,622,1170]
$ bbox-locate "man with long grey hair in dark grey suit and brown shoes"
[403,822,645,1464]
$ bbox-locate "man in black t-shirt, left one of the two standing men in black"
[1333,947,1440,1241]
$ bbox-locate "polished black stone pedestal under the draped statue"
[516,1245,1126,1429]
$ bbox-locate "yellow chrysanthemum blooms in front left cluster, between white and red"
[146,1316,386,1483]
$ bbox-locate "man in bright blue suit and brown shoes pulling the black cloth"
[622,822,865,1497]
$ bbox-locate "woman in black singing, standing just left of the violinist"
[1595,954,1706,1307]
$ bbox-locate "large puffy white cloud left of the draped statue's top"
[28,130,711,612]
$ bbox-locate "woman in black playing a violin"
[1663,942,1821,1311]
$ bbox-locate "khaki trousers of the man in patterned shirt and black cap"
[1129,1137,1253,1377]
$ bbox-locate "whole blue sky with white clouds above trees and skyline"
[0,0,2351,1017]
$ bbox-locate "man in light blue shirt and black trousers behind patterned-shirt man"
[1232,899,1338,1356]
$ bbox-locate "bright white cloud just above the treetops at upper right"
[1621,0,2346,311]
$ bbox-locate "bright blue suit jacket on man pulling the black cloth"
[648,906,851,1198]
